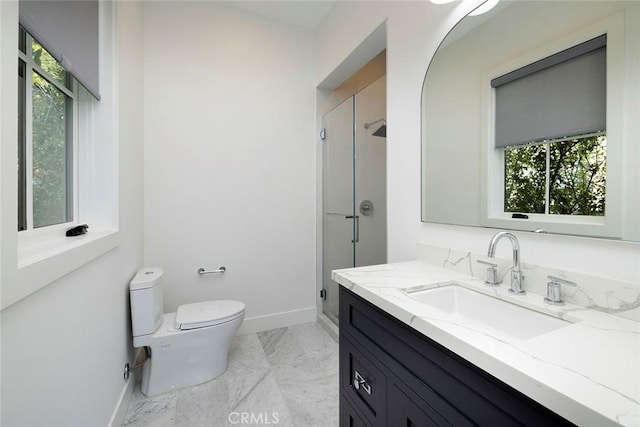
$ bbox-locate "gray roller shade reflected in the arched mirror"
[491,35,607,148]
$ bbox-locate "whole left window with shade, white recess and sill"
[0,0,120,309]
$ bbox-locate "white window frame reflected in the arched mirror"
[480,14,626,238]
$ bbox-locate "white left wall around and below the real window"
[0,2,143,427]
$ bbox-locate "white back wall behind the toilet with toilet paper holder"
[144,2,316,332]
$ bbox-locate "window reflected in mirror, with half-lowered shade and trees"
[491,35,607,219]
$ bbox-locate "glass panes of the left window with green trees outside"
[18,28,79,231]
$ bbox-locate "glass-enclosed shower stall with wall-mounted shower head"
[321,77,387,324]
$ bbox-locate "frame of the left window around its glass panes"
[18,27,79,237]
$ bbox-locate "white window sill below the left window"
[2,229,120,309]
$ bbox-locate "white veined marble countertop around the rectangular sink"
[332,261,640,426]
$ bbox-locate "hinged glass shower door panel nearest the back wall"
[322,97,358,324]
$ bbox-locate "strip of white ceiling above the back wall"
[219,0,335,30]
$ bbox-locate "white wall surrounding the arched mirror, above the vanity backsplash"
[317,0,640,281]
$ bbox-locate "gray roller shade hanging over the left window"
[20,0,100,99]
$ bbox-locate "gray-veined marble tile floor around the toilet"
[123,322,339,427]
